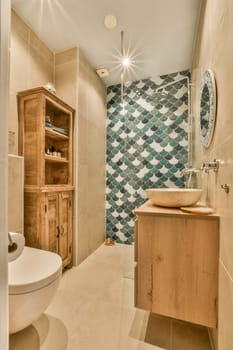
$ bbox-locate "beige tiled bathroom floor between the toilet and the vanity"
[10,244,211,350]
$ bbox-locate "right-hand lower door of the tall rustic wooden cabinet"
[59,192,72,265]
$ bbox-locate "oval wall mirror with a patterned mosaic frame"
[199,69,216,148]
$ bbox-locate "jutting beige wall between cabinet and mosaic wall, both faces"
[55,48,106,264]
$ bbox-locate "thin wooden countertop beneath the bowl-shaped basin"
[134,200,219,219]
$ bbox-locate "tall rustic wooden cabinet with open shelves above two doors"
[17,87,74,267]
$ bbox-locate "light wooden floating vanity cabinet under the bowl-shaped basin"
[135,202,219,328]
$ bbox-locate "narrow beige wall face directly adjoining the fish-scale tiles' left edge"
[77,51,106,261]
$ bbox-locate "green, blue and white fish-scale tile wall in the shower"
[106,71,189,244]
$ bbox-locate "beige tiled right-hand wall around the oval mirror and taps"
[192,0,233,350]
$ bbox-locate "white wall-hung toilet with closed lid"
[8,247,62,333]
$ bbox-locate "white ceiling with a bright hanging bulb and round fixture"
[12,0,200,85]
